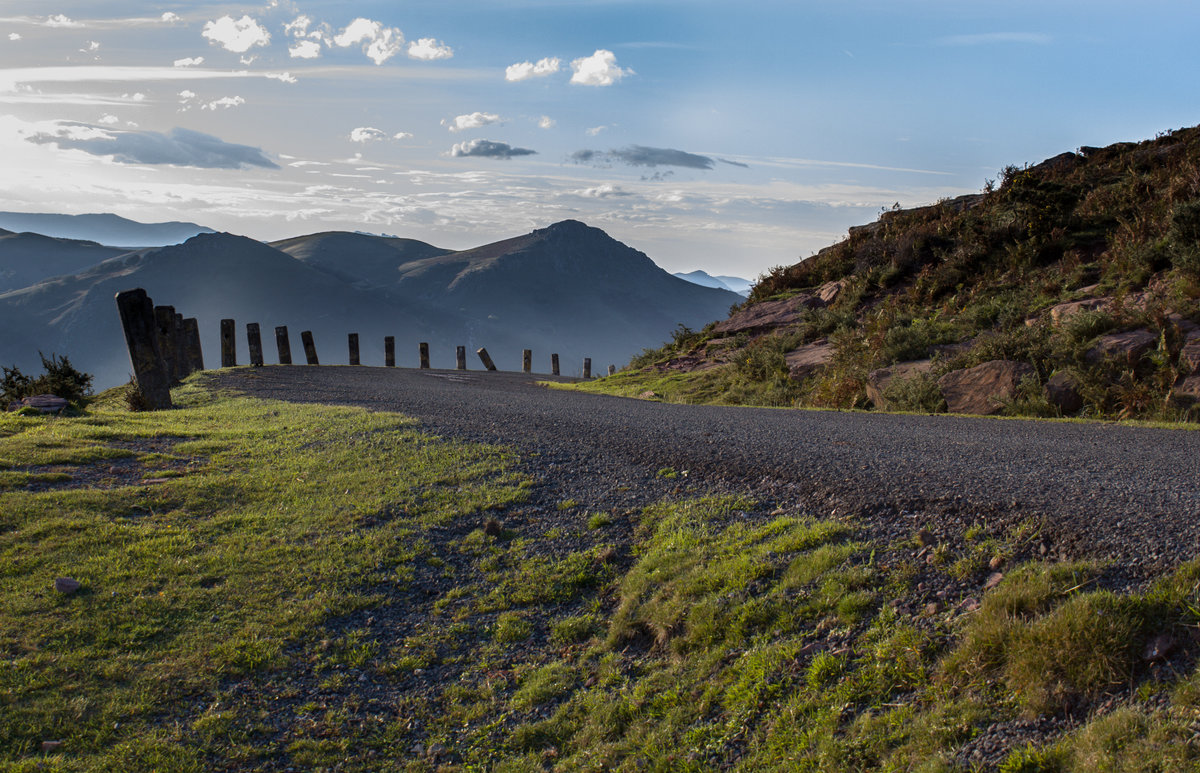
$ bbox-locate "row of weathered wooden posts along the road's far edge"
[116,288,617,409]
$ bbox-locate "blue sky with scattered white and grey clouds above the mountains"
[0,0,1200,278]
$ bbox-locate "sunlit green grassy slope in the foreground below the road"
[0,380,1200,771]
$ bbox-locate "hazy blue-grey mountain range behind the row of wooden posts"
[0,221,742,388]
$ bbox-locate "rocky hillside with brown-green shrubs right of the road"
[624,128,1200,420]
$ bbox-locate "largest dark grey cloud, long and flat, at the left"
[29,122,278,169]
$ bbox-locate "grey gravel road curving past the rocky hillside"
[216,366,1200,579]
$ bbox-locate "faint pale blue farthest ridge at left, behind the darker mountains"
[0,212,214,247]
